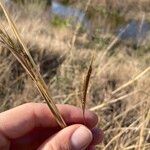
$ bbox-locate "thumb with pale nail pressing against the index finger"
[39,125,93,150]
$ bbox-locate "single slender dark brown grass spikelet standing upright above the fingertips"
[82,57,94,116]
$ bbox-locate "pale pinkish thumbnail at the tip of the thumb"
[71,126,93,150]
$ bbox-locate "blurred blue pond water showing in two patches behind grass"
[51,1,150,44]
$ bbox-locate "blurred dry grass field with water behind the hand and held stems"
[0,0,150,150]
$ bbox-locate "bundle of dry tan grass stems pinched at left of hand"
[0,2,66,128]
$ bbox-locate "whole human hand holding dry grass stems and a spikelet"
[0,103,103,150]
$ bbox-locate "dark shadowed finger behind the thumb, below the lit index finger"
[10,128,103,150]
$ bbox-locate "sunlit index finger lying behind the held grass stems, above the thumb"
[0,103,98,138]
